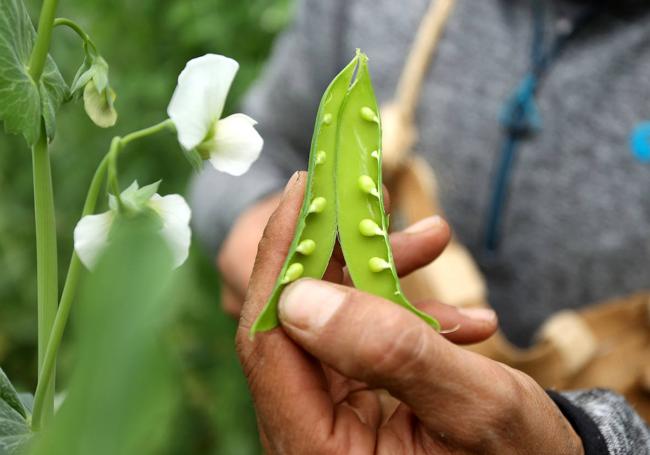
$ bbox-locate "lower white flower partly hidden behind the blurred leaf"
[74,182,192,269]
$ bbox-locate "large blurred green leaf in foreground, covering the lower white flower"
[31,216,181,455]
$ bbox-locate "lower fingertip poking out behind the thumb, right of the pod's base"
[415,301,498,344]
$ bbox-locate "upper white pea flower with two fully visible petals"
[167,54,264,175]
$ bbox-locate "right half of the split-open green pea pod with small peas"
[335,54,440,330]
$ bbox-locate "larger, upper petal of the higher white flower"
[167,54,239,150]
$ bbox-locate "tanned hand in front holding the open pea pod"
[237,175,582,455]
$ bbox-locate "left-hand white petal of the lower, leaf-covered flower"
[74,211,113,269]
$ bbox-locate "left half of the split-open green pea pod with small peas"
[251,57,358,335]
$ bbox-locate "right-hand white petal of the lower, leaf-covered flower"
[149,194,192,267]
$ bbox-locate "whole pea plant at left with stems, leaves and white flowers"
[0,0,263,454]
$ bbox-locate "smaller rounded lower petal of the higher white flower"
[205,114,264,175]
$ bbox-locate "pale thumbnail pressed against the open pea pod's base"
[278,279,345,331]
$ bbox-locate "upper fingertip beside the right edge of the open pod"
[390,215,451,276]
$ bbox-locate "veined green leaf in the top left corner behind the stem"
[0,0,67,145]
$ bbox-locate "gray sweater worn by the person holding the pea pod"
[191,0,650,454]
